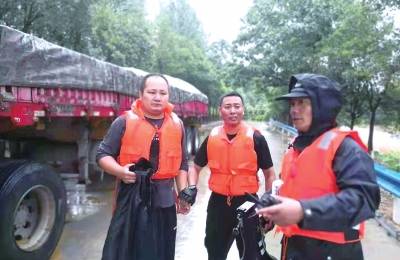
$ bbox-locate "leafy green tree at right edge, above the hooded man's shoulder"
[320,2,397,151]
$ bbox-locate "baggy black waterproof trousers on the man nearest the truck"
[102,181,177,260]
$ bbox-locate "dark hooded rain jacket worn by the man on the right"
[282,74,380,259]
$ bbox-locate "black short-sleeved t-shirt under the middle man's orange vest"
[194,131,273,170]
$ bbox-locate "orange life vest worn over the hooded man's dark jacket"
[278,129,367,244]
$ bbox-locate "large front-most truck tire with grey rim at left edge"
[0,160,66,260]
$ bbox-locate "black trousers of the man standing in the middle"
[204,192,270,260]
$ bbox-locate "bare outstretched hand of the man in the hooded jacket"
[256,196,304,227]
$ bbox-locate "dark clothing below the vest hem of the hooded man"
[281,236,364,260]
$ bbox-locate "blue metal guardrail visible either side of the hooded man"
[268,119,400,198]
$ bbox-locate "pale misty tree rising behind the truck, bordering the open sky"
[153,0,220,111]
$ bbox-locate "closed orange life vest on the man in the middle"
[207,124,258,196]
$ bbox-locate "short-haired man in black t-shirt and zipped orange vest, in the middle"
[184,92,275,260]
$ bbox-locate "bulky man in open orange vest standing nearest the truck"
[96,74,188,260]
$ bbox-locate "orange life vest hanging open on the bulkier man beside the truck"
[118,99,182,179]
